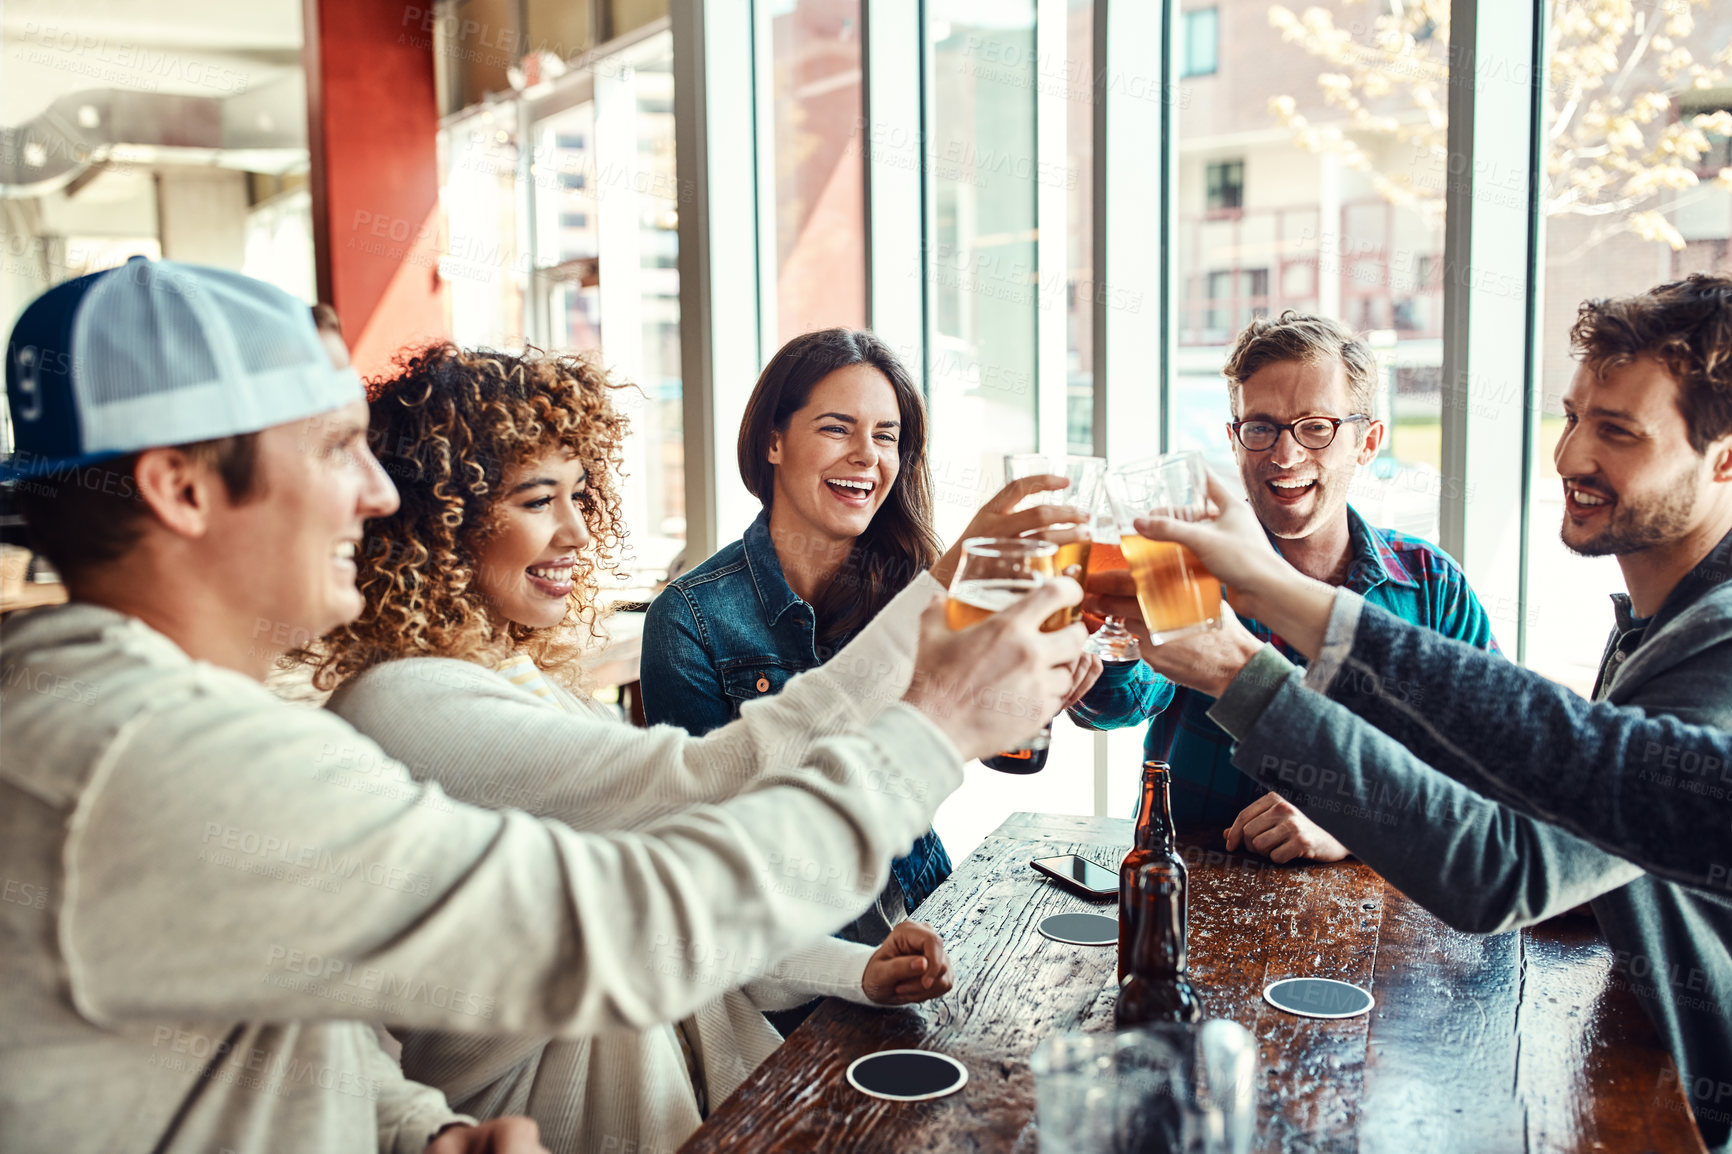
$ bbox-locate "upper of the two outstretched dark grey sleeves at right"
[1328,594,1732,892]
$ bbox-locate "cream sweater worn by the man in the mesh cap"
[0,571,963,1154]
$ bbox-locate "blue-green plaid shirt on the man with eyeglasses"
[1070,506,1498,832]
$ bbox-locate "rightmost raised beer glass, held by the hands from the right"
[1107,452,1221,645]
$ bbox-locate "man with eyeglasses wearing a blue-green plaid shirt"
[1070,310,1496,861]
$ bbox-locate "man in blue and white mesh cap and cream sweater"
[0,262,1081,1154]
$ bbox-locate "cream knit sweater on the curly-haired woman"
[329,577,939,1154]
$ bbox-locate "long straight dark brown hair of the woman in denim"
[740,329,940,641]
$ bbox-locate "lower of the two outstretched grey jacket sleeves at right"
[1209,646,1642,934]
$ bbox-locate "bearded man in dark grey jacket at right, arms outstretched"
[1091,277,1732,1151]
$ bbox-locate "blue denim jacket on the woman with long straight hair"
[641,509,951,922]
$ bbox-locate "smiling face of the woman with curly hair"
[476,447,591,629]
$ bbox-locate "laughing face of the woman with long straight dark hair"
[769,364,902,551]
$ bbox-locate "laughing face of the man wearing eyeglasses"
[1228,359,1384,548]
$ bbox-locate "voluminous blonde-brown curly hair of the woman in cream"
[310,343,627,690]
